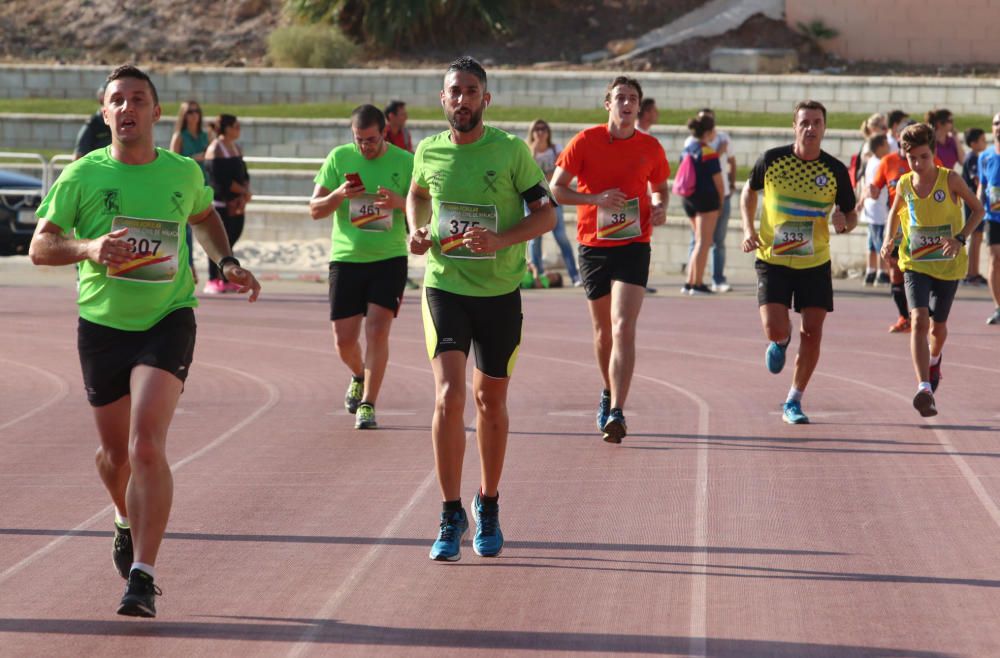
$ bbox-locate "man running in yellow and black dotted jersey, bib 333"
[740,101,858,424]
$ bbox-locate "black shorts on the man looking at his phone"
[330,256,406,320]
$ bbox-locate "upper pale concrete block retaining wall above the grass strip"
[0,64,1000,114]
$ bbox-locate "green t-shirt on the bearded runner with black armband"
[413,126,545,297]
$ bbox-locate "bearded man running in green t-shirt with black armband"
[406,57,556,560]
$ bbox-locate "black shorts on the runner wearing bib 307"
[76,308,196,407]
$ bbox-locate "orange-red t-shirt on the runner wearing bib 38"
[556,125,670,247]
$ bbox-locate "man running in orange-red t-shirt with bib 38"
[551,76,670,443]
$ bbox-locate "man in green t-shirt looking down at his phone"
[309,105,413,429]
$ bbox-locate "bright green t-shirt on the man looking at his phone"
[314,143,413,263]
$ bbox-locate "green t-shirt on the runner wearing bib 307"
[38,147,212,331]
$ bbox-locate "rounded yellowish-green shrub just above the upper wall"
[267,25,358,69]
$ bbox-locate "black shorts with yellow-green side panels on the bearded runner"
[421,287,523,379]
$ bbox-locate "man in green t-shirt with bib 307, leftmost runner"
[29,65,260,617]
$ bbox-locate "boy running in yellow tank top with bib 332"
[882,124,984,416]
